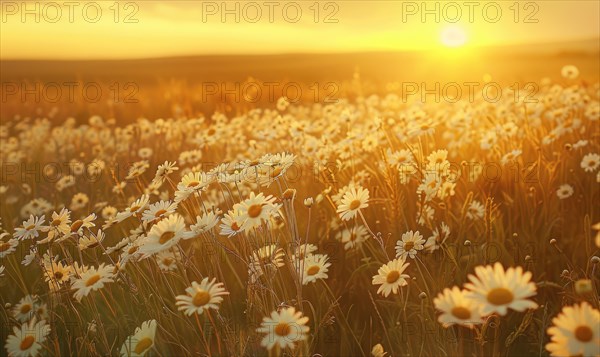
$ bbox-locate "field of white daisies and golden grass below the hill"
[0,67,600,357]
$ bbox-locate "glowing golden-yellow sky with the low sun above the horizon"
[0,0,600,59]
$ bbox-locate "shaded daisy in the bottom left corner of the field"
[5,317,50,357]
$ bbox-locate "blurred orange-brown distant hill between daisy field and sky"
[0,39,600,83]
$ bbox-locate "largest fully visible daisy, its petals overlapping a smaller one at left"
[465,263,538,316]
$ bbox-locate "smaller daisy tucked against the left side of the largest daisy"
[433,286,483,328]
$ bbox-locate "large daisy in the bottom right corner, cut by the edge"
[546,301,600,356]
